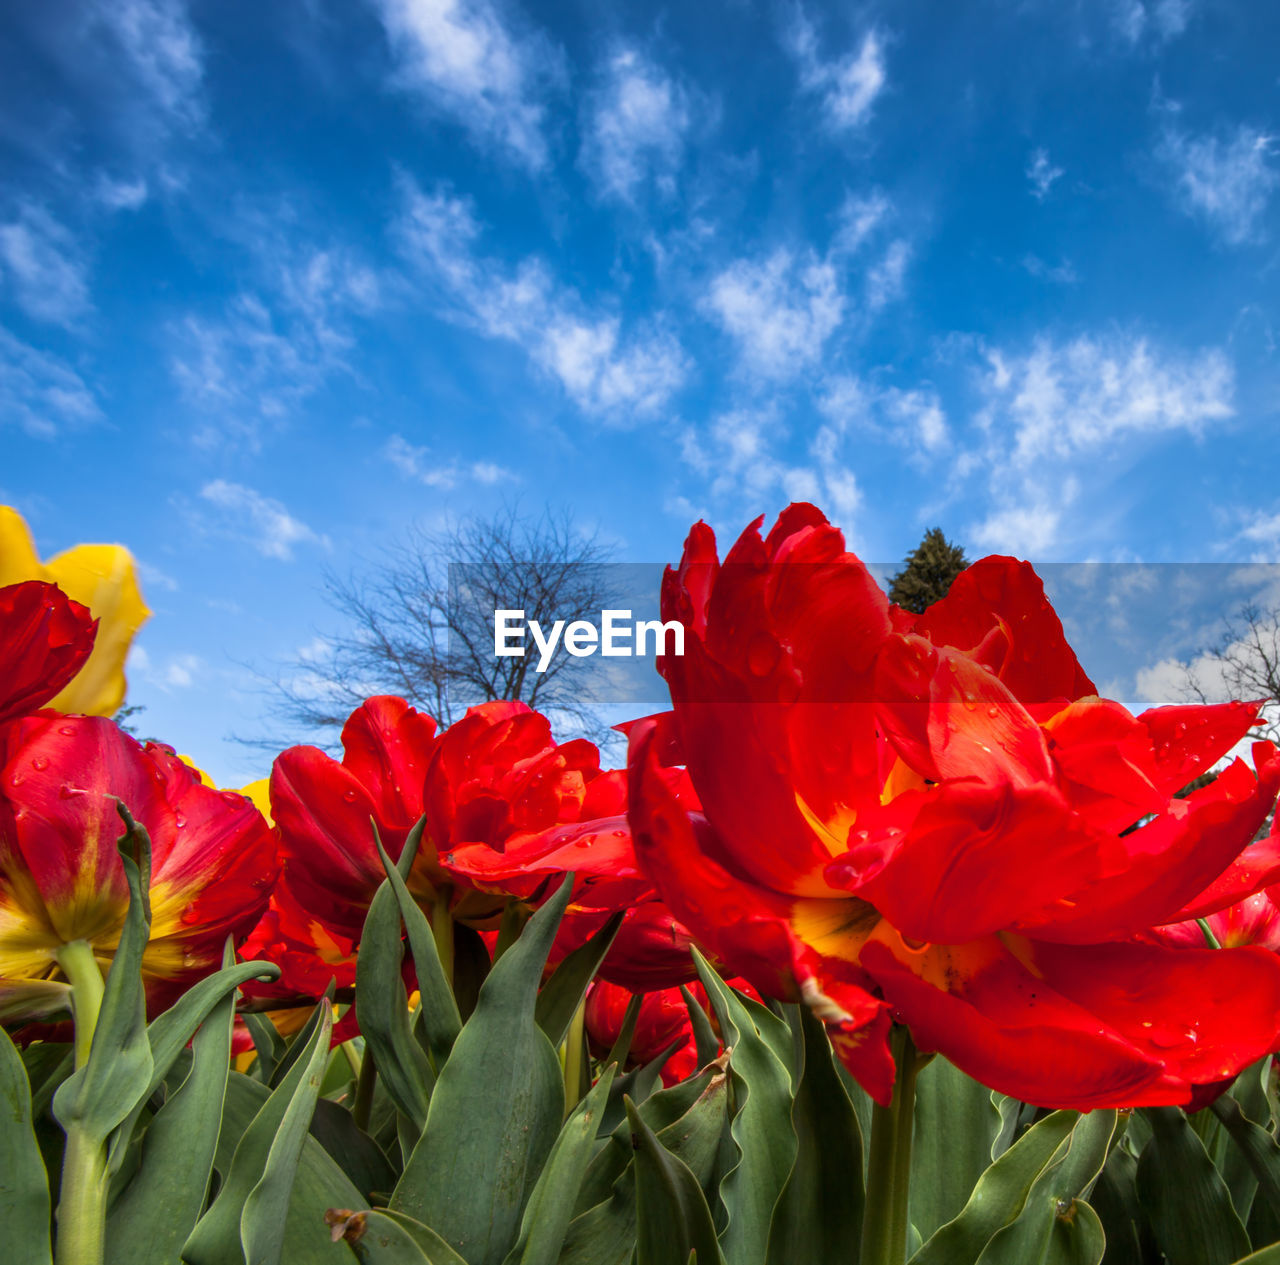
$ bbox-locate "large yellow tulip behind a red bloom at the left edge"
[0,506,151,716]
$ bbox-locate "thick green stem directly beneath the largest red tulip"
[859,1024,919,1265]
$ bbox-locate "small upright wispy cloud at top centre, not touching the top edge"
[580,49,690,201]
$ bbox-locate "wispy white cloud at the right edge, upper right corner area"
[1158,127,1280,246]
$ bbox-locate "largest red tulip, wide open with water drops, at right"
[630,506,1280,1108]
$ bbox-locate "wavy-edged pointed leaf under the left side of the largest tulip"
[692,949,796,1265]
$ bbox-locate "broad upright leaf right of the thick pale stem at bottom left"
[106,947,236,1265]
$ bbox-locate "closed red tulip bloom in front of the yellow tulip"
[0,580,97,723]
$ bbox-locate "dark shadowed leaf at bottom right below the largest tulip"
[1138,1108,1249,1265]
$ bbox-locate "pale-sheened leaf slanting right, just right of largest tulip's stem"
[910,1111,1079,1265]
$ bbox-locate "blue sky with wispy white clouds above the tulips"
[0,0,1280,784]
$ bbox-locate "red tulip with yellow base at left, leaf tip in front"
[0,713,276,1015]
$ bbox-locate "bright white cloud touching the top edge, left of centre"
[374,0,558,170]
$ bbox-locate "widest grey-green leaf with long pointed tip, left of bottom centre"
[386,876,573,1265]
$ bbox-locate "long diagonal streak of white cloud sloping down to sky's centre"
[396,181,687,420]
